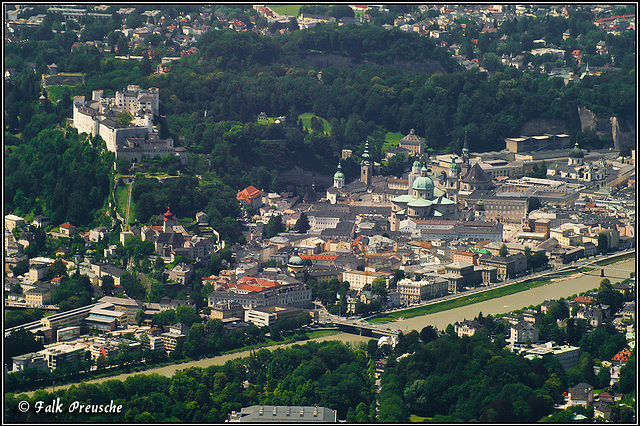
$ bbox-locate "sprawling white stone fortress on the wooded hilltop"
[73,85,188,163]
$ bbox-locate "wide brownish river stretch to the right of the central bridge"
[392,258,636,332]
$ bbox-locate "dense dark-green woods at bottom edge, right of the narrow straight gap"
[379,333,566,422]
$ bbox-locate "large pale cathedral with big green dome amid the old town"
[389,161,457,231]
